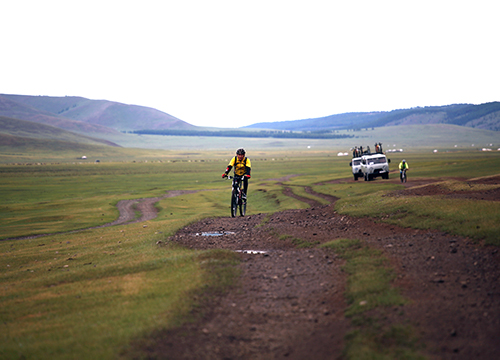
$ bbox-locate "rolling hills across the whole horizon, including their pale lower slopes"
[0,95,500,152]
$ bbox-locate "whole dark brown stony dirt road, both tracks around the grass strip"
[129,176,500,360]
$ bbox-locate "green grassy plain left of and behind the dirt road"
[0,146,500,359]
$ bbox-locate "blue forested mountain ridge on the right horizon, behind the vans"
[246,102,500,131]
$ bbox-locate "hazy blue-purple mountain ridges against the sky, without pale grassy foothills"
[0,94,500,141]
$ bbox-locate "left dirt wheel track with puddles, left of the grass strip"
[133,188,350,359]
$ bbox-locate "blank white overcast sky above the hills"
[0,0,500,128]
